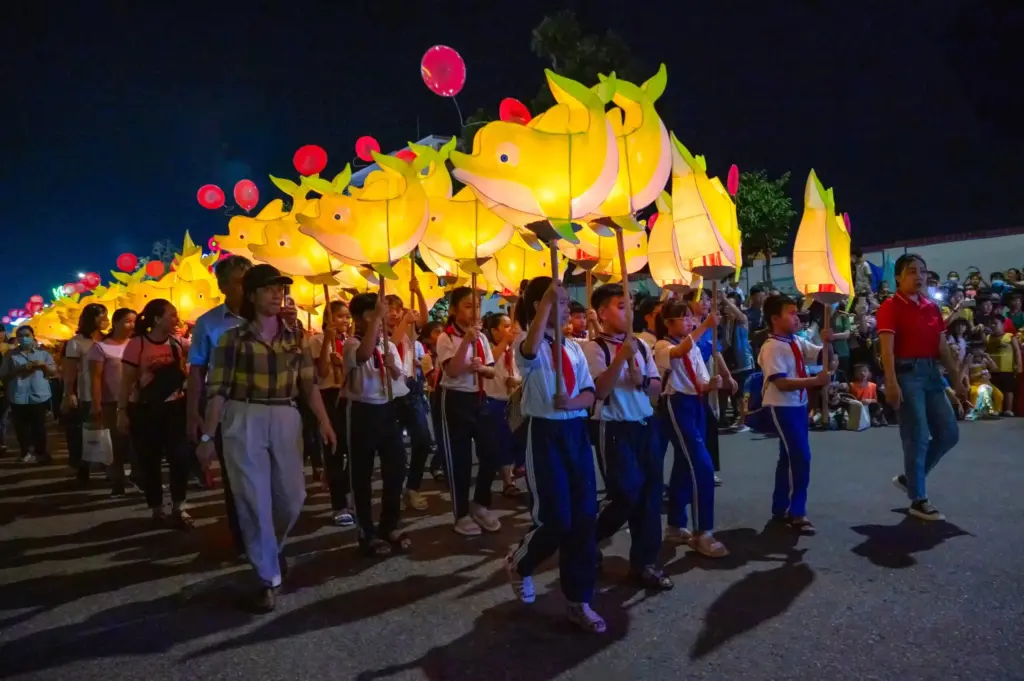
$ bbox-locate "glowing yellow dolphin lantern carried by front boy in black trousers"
[298,152,428,279]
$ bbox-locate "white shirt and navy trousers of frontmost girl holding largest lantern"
[509,337,597,603]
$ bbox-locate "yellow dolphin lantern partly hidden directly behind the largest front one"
[589,63,672,231]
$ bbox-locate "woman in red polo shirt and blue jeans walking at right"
[877,253,963,520]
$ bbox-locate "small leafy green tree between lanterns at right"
[736,170,797,284]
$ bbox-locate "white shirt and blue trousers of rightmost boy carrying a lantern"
[758,334,821,517]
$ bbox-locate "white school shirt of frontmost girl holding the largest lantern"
[515,336,594,421]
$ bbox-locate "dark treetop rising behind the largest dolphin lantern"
[459,9,638,154]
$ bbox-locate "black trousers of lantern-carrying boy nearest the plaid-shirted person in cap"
[345,400,406,546]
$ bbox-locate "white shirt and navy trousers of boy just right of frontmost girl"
[584,334,665,571]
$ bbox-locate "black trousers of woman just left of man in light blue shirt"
[128,399,189,509]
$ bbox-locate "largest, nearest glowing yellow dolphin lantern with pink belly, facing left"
[452,71,618,243]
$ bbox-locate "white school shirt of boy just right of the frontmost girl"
[583,335,658,422]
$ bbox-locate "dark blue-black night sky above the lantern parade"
[0,0,1024,310]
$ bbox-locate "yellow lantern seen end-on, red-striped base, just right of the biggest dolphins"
[658,134,742,280]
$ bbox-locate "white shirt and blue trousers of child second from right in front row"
[654,338,715,533]
